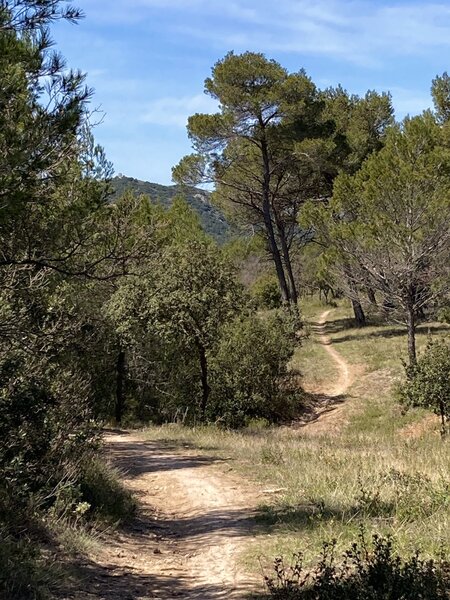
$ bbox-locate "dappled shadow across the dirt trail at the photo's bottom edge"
[62,560,251,600]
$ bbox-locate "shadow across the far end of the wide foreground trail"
[103,440,222,478]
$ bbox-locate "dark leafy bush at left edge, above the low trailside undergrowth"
[0,358,98,517]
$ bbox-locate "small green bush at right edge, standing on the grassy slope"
[397,340,450,435]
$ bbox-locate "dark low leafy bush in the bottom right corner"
[266,532,450,600]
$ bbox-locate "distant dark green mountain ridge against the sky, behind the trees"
[111,175,230,243]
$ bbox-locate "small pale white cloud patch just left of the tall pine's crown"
[141,94,218,127]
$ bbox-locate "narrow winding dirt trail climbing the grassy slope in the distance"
[303,309,361,435]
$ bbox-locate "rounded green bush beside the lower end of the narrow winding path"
[208,313,300,427]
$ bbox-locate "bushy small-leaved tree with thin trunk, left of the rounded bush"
[105,226,244,420]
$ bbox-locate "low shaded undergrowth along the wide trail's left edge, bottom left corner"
[0,455,136,600]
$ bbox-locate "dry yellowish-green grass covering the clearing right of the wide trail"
[142,303,450,569]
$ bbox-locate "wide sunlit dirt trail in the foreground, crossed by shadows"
[68,432,258,600]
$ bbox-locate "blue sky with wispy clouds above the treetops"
[53,0,450,184]
